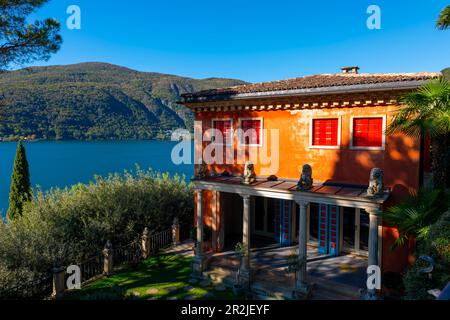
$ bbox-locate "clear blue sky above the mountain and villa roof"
[29,0,450,82]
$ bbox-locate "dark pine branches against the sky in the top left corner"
[0,0,62,70]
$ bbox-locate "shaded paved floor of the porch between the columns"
[205,245,367,300]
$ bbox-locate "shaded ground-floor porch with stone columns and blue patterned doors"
[193,177,389,299]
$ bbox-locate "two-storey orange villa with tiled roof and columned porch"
[182,67,440,298]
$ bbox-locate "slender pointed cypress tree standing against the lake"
[7,141,32,219]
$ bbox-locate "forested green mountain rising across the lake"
[0,62,245,140]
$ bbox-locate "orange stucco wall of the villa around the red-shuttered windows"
[196,104,420,271]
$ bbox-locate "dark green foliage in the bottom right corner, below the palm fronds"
[403,212,450,300]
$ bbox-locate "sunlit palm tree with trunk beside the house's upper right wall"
[387,77,450,188]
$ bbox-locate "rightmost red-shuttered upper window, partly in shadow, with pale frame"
[352,117,385,149]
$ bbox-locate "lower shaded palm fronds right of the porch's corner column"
[382,189,450,249]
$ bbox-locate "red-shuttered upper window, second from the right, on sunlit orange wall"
[311,119,340,147]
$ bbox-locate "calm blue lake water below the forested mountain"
[0,141,194,215]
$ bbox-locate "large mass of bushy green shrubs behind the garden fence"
[0,168,194,297]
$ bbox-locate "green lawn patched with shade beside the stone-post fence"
[67,254,236,300]
